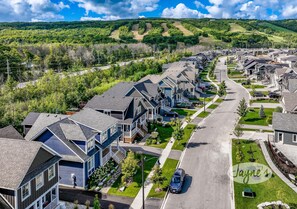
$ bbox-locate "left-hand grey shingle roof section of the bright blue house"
[25,113,69,140]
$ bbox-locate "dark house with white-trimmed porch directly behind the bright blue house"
[86,95,148,143]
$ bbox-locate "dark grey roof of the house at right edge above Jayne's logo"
[272,112,297,133]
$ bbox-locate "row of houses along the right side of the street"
[237,50,297,146]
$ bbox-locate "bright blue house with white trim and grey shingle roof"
[25,108,125,188]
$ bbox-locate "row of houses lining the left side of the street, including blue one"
[0,52,220,209]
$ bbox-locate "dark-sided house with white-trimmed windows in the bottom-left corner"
[0,138,61,209]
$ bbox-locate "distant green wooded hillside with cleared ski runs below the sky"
[0,19,297,50]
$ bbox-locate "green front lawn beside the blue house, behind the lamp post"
[108,155,158,198]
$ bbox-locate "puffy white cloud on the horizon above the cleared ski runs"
[162,3,206,18]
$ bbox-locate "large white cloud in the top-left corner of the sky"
[0,0,70,22]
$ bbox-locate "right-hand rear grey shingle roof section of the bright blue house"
[70,108,118,132]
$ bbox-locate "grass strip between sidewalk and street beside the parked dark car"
[148,158,178,198]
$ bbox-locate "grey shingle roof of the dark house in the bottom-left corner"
[0,138,60,190]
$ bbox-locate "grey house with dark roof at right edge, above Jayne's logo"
[272,112,297,146]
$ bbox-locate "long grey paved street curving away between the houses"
[165,58,248,209]
